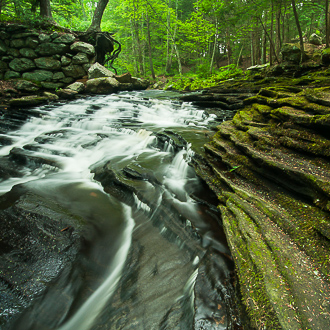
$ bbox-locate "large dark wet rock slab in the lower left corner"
[0,186,84,324]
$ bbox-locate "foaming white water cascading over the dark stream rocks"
[0,92,224,330]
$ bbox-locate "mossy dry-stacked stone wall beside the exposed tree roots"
[0,24,95,90]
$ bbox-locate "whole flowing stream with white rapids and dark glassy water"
[0,91,239,330]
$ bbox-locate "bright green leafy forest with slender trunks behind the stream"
[0,0,330,78]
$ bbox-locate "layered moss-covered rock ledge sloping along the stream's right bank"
[196,87,330,330]
